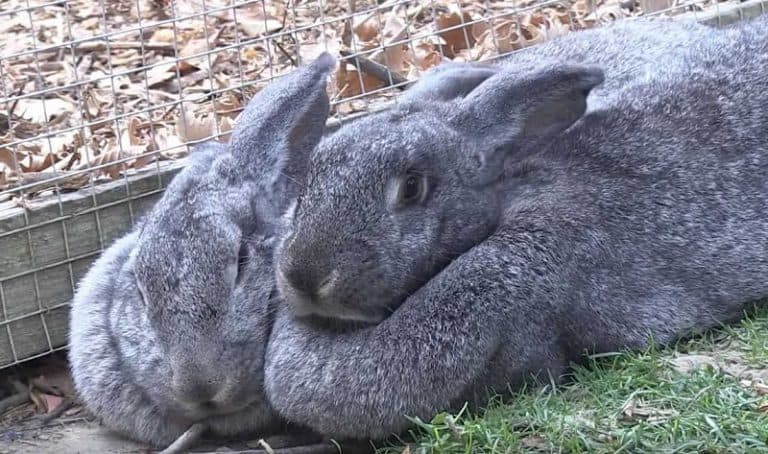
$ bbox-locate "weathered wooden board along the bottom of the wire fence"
[0,0,768,369]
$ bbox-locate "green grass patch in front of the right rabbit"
[380,310,768,454]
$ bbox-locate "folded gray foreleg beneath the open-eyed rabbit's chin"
[265,225,564,439]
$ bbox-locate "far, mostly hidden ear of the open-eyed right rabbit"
[399,62,499,103]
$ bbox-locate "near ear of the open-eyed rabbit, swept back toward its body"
[454,64,605,184]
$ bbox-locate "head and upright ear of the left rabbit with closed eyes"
[124,54,335,419]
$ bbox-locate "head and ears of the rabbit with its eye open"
[276,64,604,323]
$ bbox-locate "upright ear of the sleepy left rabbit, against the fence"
[230,52,336,204]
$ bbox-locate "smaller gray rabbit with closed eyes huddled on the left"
[69,54,335,446]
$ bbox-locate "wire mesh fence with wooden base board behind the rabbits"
[0,0,765,368]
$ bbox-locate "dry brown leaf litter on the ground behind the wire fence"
[0,0,732,204]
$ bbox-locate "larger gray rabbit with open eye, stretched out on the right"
[265,13,768,438]
